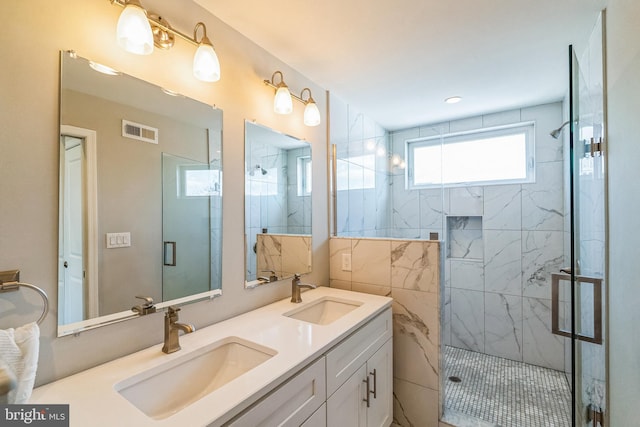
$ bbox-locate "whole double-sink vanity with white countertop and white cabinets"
[30,287,392,427]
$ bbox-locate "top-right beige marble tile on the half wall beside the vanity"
[391,240,440,293]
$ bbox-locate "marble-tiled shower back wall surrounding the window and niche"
[389,103,564,370]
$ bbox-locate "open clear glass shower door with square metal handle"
[559,22,607,427]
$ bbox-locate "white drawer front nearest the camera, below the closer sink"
[225,357,326,427]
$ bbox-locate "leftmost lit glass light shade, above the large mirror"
[116,4,153,55]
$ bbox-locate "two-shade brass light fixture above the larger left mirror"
[109,0,220,82]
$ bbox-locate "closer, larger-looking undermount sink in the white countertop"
[115,337,277,420]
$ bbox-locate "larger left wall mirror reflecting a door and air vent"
[58,52,222,336]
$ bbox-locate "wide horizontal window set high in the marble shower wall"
[406,123,535,188]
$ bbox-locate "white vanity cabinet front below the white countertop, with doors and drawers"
[225,308,393,427]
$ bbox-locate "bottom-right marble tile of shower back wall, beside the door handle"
[523,298,565,370]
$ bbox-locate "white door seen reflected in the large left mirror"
[62,136,85,324]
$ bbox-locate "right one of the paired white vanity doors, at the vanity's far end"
[367,340,393,427]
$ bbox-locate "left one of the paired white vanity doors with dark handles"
[327,365,367,427]
